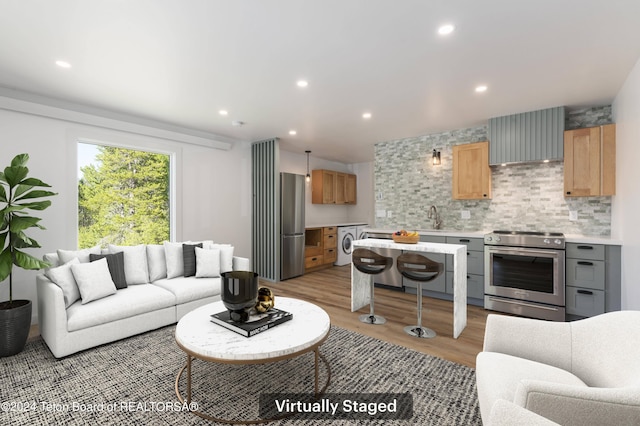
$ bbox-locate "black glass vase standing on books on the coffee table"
[222,271,258,322]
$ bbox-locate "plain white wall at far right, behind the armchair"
[611,55,640,310]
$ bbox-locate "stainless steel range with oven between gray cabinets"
[484,231,565,321]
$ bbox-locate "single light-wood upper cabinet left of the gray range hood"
[452,142,491,200]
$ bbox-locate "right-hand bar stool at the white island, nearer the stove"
[397,253,444,338]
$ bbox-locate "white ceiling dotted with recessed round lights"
[0,0,640,163]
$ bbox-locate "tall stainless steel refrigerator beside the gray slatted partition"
[280,173,305,280]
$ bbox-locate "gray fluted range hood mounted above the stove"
[488,107,565,166]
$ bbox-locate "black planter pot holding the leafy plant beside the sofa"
[0,300,32,357]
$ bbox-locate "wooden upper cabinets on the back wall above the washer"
[311,170,357,204]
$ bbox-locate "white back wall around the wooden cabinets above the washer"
[280,150,374,227]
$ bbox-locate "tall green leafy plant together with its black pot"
[0,154,56,357]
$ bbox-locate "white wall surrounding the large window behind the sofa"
[0,99,251,322]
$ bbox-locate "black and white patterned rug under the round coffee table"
[0,326,481,425]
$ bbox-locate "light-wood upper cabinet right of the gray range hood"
[564,124,616,197]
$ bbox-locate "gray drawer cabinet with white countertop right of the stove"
[565,243,621,319]
